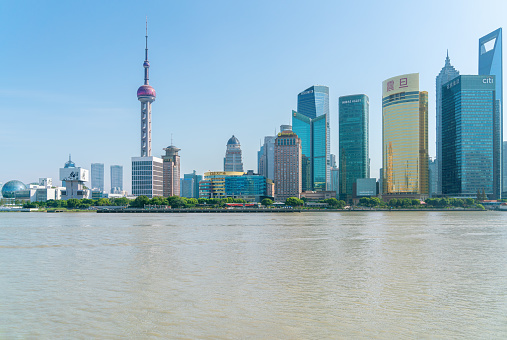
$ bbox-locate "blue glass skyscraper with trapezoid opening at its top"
[479,28,503,198]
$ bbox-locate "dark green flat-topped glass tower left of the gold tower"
[338,94,370,202]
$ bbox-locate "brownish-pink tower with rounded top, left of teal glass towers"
[275,130,302,202]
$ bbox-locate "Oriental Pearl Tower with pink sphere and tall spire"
[137,19,156,157]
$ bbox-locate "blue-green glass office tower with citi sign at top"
[442,75,500,199]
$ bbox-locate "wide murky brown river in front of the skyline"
[0,211,507,339]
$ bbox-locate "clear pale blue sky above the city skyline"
[0,0,507,192]
